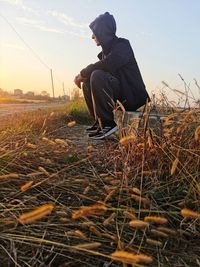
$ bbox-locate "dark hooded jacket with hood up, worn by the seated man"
[80,12,149,111]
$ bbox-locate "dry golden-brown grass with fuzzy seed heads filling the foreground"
[0,99,200,267]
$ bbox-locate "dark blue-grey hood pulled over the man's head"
[89,12,116,47]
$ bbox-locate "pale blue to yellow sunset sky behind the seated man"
[0,0,200,98]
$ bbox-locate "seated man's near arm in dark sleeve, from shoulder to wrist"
[80,42,133,78]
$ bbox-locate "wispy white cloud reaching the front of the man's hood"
[47,10,89,38]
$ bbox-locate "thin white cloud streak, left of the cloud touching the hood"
[16,17,64,34]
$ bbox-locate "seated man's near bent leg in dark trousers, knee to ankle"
[90,70,120,126]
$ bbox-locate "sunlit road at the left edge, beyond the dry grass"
[0,102,66,118]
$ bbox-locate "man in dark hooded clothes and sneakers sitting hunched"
[74,12,149,140]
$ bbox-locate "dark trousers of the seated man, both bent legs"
[82,70,120,122]
